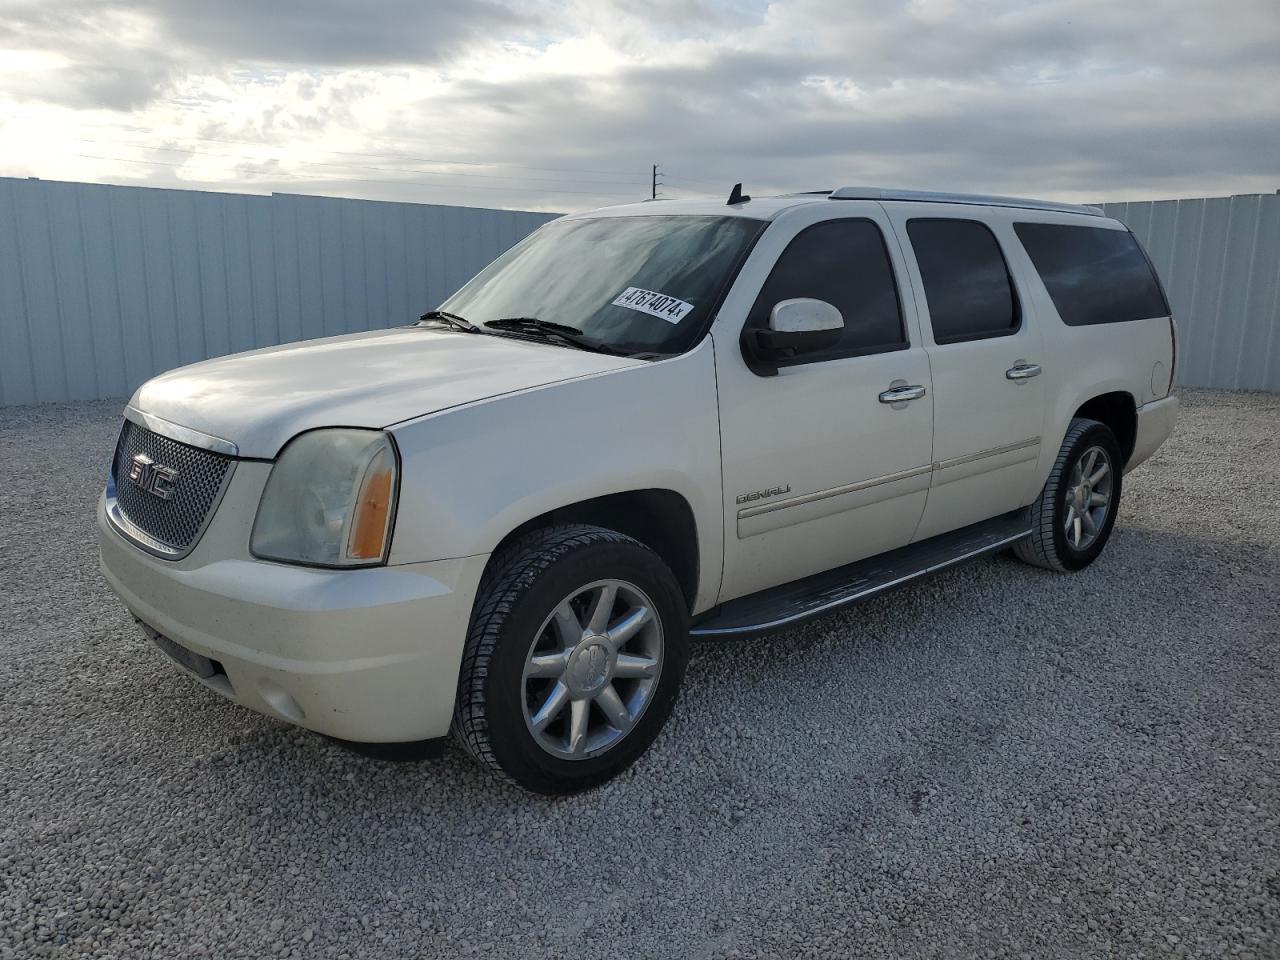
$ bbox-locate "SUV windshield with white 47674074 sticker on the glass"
[440,216,765,353]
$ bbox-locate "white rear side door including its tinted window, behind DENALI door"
[888,204,1048,540]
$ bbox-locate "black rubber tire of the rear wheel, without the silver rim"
[1014,417,1124,572]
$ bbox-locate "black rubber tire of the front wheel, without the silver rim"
[452,524,689,794]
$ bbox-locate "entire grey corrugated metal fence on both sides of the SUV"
[0,178,1280,406]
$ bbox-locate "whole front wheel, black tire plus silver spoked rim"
[453,525,689,794]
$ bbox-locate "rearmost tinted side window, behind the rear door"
[1014,223,1169,326]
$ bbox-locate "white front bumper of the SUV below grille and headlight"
[97,491,488,742]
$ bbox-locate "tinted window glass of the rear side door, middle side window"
[906,220,1020,343]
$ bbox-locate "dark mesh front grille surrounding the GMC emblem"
[111,420,233,553]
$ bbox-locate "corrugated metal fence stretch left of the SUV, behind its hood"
[0,178,552,406]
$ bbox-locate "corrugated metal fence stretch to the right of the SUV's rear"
[1102,193,1280,392]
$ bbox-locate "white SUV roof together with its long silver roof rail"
[567,187,1105,220]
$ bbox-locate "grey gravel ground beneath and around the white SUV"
[0,393,1280,960]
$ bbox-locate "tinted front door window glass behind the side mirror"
[746,220,906,365]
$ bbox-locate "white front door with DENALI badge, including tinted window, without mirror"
[713,207,933,603]
